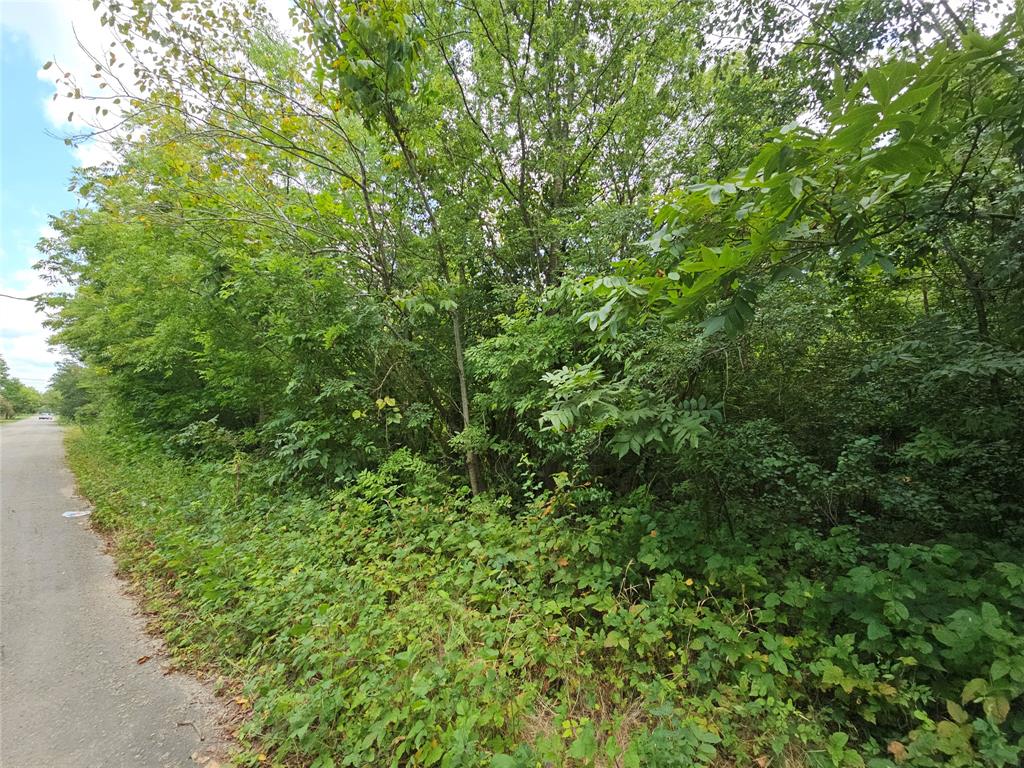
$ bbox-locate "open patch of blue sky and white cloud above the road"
[0,0,76,389]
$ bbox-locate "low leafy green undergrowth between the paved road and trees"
[68,430,1024,768]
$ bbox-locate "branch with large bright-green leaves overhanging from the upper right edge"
[581,17,1024,336]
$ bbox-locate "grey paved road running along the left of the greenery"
[0,419,228,768]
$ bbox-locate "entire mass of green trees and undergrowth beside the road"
[39,0,1024,768]
